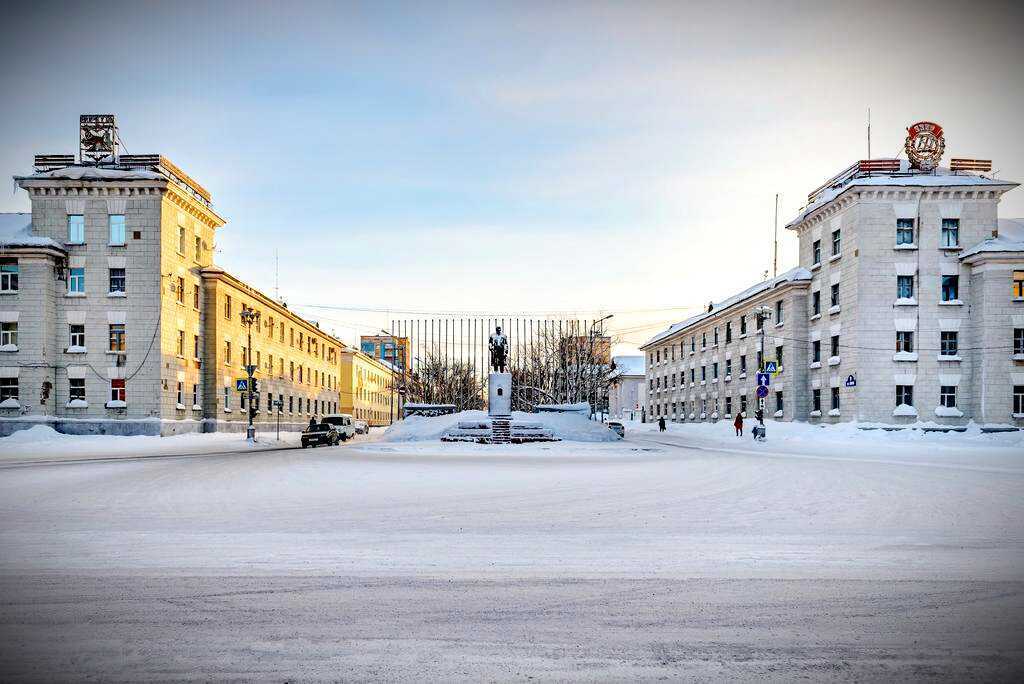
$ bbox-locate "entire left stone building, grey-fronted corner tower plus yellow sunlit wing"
[0,117,344,434]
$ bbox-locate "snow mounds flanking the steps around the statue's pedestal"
[383,411,618,441]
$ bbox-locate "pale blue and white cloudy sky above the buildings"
[0,0,1024,353]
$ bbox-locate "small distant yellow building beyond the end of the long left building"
[341,348,400,425]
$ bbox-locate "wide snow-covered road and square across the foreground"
[0,433,1024,681]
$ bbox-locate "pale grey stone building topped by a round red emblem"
[642,122,1024,427]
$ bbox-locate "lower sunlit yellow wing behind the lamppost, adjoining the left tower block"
[202,266,344,429]
